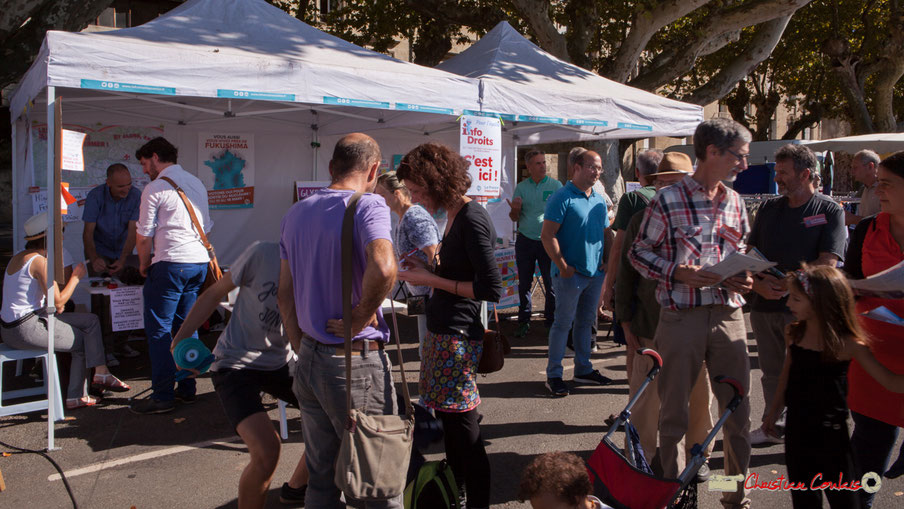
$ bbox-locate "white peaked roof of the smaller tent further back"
[437,21,703,142]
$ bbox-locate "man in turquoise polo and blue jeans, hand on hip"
[540,150,612,396]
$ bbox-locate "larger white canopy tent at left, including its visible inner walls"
[10,0,488,447]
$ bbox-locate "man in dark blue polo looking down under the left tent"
[82,163,141,276]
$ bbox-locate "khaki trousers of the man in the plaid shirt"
[654,305,750,508]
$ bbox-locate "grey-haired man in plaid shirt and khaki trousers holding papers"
[629,118,753,508]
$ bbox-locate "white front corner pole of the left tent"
[44,86,62,451]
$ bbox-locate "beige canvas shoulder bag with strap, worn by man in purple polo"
[333,193,414,501]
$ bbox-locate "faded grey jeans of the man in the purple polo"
[292,337,405,509]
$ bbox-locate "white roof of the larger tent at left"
[10,0,479,129]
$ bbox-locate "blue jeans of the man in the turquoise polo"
[546,272,603,378]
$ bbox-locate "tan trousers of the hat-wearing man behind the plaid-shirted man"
[628,337,716,463]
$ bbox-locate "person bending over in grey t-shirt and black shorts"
[172,242,308,507]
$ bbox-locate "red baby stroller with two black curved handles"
[587,348,744,509]
